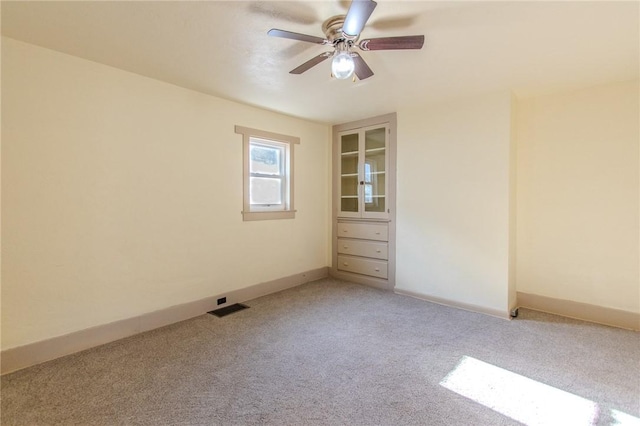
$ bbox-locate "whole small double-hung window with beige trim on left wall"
[236,126,300,220]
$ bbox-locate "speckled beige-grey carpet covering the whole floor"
[1,279,640,425]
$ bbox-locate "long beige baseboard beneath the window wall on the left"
[0,267,329,374]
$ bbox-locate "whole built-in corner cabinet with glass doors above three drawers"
[332,114,396,289]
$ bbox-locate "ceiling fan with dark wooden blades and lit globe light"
[267,0,424,81]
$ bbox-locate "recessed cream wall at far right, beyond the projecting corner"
[517,81,640,312]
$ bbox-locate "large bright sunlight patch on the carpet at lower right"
[440,356,599,426]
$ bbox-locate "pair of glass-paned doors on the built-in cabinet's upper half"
[339,126,388,218]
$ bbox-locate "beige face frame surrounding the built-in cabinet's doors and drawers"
[330,113,397,290]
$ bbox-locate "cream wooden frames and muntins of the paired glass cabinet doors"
[335,123,390,219]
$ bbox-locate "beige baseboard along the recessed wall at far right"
[518,292,640,331]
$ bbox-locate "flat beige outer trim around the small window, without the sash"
[235,126,300,221]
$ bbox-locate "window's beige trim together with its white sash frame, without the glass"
[235,126,300,221]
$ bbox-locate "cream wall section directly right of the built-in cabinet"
[396,93,515,315]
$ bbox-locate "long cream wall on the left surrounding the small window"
[2,39,330,349]
